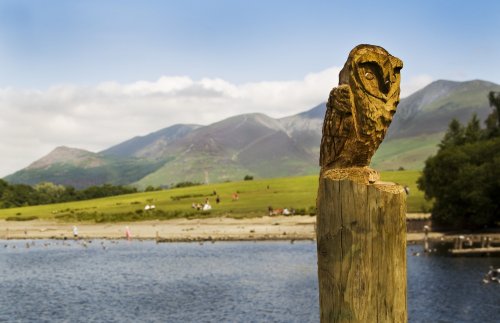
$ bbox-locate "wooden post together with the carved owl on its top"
[317,45,407,322]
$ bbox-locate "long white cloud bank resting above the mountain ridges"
[0,67,431,176]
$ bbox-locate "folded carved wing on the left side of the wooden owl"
[320,84,355,167]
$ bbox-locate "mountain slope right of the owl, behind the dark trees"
[371,80,500,170]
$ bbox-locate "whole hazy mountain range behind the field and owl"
[5,80,500,188]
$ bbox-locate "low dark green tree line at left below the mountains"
[0,179,137,208]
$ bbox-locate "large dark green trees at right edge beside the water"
[418,92,500,229]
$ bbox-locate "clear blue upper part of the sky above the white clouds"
[0,0,500,88]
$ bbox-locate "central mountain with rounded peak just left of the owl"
[131,113,313,187]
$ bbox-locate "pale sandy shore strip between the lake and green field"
[0,216,443,242]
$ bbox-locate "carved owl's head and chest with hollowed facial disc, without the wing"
[339,44,403,139]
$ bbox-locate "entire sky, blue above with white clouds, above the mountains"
[0,0,500,177]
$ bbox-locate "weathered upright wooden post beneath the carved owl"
[317,173,407,322]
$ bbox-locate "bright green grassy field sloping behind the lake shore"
[0,171,430,222]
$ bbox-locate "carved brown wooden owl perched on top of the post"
[320,45,403,169]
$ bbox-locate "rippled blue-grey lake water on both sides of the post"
[0,240,500,322]
